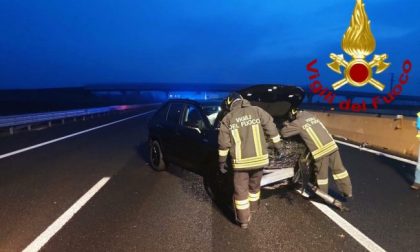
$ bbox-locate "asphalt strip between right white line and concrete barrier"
[334,146,420,251]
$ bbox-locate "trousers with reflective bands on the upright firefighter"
[233,169,263,223]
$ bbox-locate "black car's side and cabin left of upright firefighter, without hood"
[149,100,220,174]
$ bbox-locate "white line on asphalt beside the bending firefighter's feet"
[311,201,386,252]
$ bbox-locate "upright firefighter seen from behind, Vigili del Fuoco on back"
[218,93,281,229]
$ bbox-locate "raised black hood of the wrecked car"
[238,84,305,118]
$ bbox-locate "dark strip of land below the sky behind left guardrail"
[0,88,162,116]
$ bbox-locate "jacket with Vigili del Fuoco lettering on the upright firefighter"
[218,99,280,170]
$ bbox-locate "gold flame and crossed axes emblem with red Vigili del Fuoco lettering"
[306,0,412,112]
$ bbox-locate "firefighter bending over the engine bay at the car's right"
[280,109,352,198]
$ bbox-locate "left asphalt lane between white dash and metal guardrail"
[0,108,154,251]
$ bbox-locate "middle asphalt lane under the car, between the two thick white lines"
[40,152,362,251]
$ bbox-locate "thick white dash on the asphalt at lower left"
[23,177,110,252]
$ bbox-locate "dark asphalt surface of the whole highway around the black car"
[0,107,420,251]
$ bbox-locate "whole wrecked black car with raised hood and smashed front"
[149,85,346,211]
